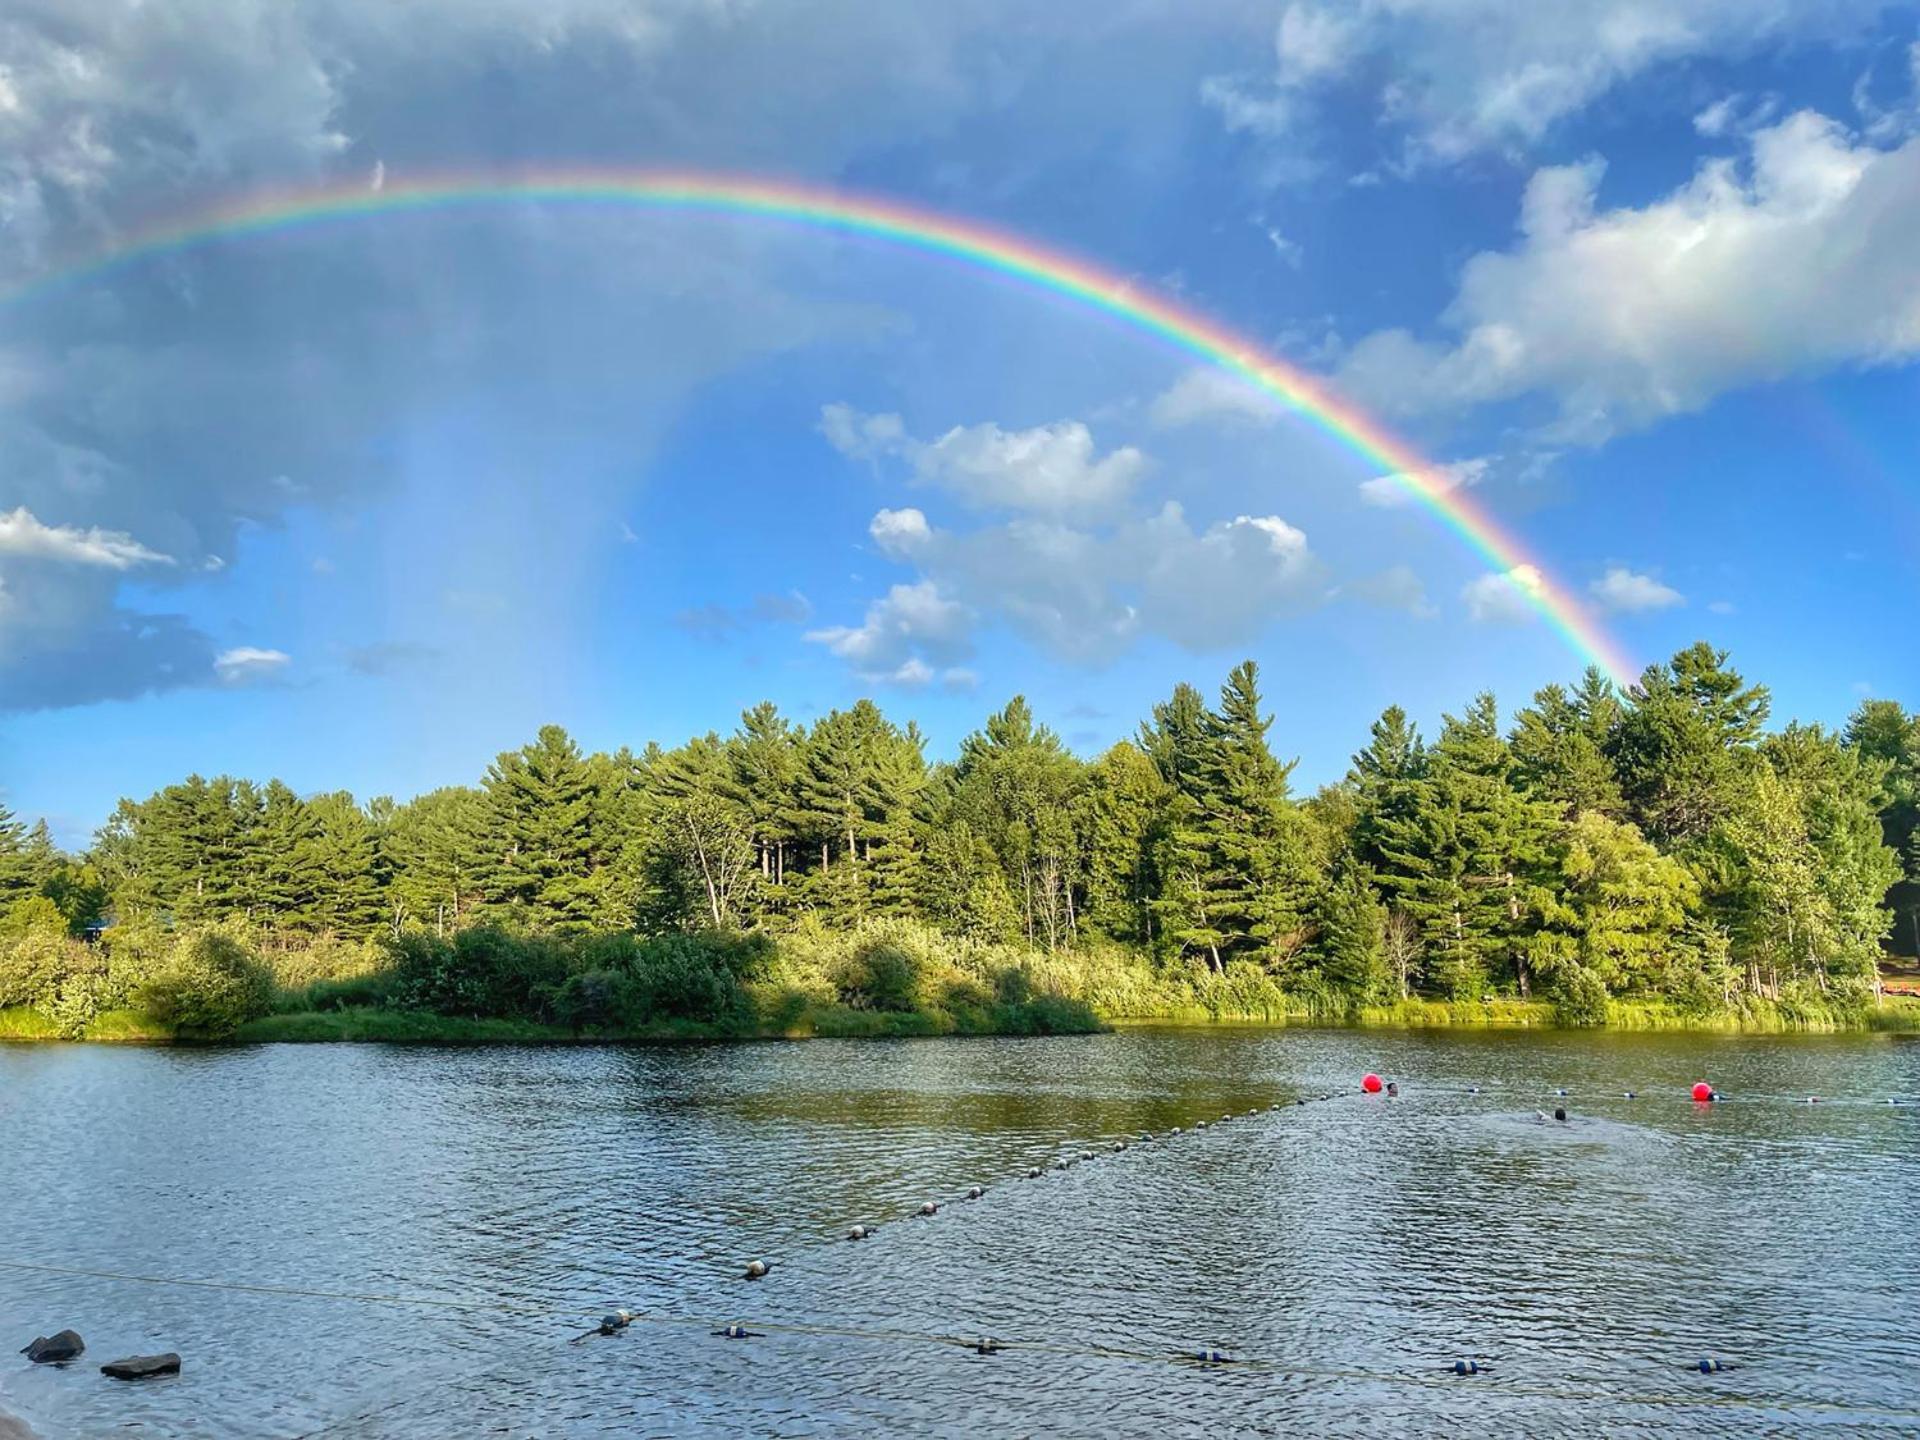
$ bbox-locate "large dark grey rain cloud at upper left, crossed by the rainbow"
[0,0,1290,705]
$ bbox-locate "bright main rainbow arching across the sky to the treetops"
[11,171,1634,685]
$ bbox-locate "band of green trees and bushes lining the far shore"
[0,643,1920,1037]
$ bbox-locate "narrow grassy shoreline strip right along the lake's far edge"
[0,996,1920,1052]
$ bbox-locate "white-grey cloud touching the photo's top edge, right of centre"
[1202,0,1884,163]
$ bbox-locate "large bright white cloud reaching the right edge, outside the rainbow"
[1338,111,1920,444]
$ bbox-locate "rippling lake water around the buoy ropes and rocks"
[0,1029,1920,1440]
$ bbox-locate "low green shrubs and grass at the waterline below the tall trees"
[0,922,1920,1044]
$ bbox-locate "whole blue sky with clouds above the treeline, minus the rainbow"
[0,0,1920,843]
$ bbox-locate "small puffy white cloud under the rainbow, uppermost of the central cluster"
[820,405,1148,515]
